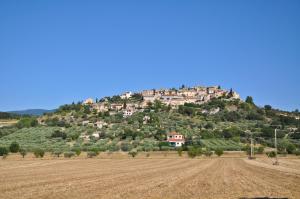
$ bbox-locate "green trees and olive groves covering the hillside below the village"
[0,95,300,156]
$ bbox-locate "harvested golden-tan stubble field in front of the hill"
[0,158,300,199]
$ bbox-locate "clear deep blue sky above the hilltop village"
[0,0,300,111]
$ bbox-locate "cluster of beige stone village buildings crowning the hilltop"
[83,86,240,117]
